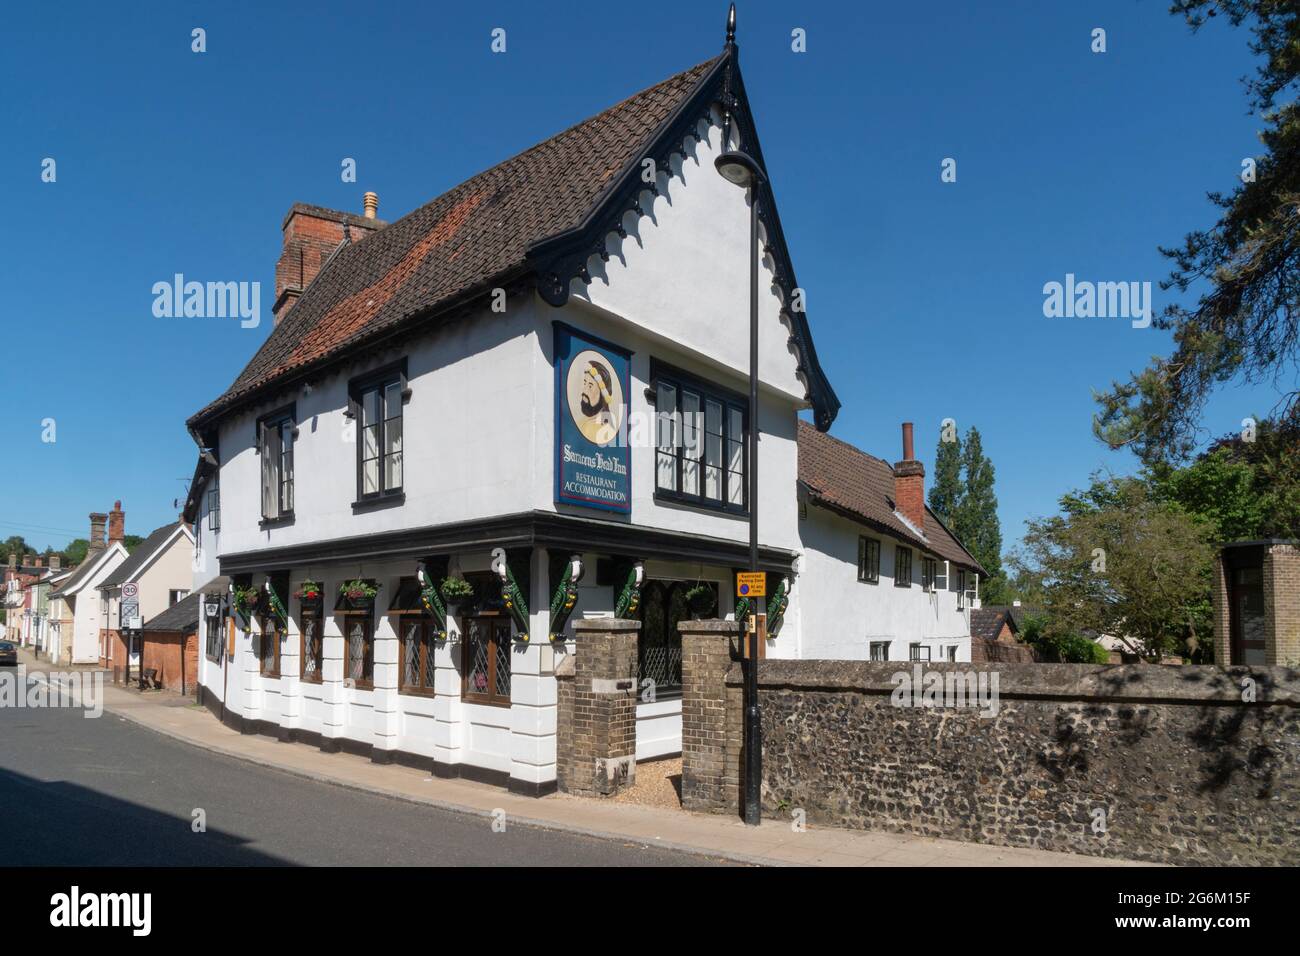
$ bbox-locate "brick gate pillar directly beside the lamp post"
[679,620,740,813]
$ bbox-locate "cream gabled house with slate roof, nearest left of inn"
[98,520,194,683]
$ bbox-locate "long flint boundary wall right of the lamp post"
[707,659,1300,865]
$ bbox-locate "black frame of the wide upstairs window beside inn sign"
[647,356,753,516]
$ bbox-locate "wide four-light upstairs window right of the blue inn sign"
[651,367,749,514]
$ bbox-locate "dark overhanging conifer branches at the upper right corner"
[1093,0,1300,464]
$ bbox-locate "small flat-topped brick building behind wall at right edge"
[1214,538,1300,667]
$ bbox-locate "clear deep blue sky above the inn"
[0,0,1275,546]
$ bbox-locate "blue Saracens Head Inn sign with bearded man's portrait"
[555,323,632,514]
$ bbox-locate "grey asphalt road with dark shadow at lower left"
[0,669,710,866]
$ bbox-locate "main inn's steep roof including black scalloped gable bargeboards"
[189,44,840,432]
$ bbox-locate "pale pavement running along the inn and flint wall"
[10,652,1147,866]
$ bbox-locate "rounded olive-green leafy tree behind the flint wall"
[1013,475,1214,661]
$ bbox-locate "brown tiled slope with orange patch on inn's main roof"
[190,57,719,427]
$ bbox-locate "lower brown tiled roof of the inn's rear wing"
[798,419,987,574]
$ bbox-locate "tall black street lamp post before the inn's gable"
[714,145,763,826]
